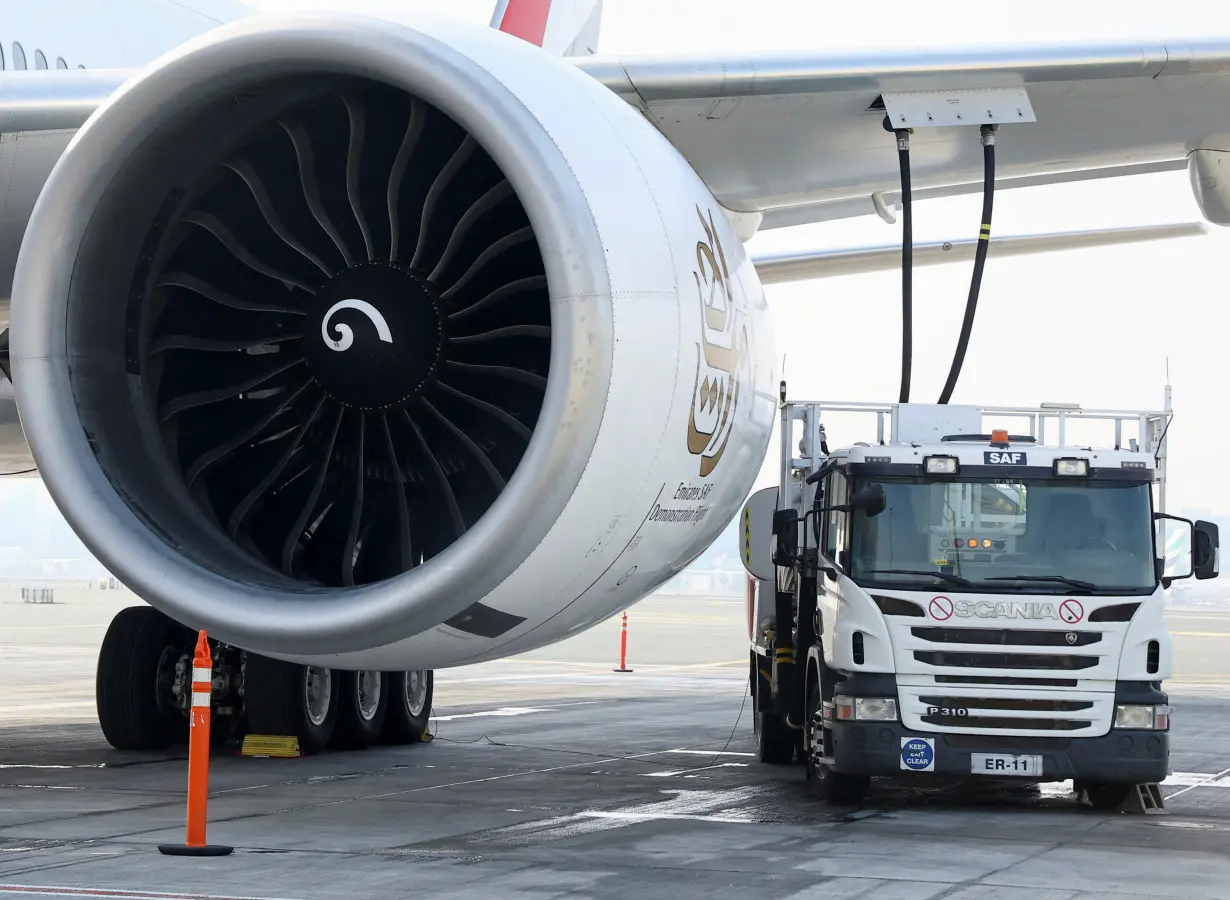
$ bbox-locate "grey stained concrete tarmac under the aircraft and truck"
[0,591,1230,900]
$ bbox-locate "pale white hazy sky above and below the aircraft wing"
[244,0,1230,510]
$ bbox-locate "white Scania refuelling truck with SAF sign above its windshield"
[744,387,1218,808]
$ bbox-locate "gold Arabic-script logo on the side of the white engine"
[688,207,748,478]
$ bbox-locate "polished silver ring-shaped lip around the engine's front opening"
[12,14,611,655]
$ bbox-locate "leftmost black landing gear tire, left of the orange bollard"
[95,606,189,750]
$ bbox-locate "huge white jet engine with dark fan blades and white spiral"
[11,14,776,668]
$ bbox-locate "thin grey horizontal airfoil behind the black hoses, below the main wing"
[752,223,1208,284]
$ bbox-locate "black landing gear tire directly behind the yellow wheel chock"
[244,653,339,756]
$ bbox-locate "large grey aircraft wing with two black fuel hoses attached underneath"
[576,36,1230,227]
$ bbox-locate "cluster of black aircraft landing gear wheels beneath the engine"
[96,606,434,755]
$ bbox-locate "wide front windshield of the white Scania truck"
[850,478,1157,594]
